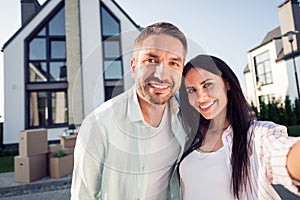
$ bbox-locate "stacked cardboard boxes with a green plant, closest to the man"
[49,135,77,178]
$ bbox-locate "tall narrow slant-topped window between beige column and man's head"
[101,5,124,100]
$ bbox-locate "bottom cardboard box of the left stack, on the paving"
[14,154,47,183]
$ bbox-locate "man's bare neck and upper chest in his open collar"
[137,95,167,127]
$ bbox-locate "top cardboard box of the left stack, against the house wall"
[19,129,48,156]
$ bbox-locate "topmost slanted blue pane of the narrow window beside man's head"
[101,7,120,36]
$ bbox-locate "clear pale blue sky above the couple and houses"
[0,0,285,122]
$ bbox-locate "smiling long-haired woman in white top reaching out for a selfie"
[179,55,300,200]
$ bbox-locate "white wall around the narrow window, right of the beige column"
[80,0,139,116]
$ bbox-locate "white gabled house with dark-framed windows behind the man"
[2,0,140,144]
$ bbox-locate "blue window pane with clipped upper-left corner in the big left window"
[29,38,46,60]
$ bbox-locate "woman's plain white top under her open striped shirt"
[179,147,234,200]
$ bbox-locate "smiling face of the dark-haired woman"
[185,68,230,120]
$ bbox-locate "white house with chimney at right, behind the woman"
[244,0,300,108]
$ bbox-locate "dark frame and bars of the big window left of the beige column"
[24,2,69,129]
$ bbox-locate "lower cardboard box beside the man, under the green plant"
[50,154,74,178]
